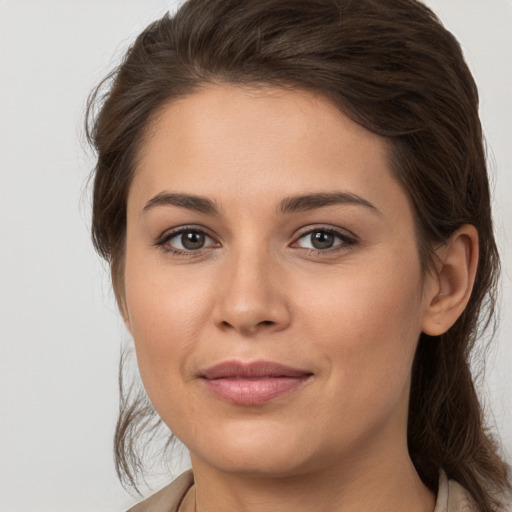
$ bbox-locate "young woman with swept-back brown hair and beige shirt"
[86,0,510,512]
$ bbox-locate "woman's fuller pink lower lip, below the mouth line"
[204,375,310,405]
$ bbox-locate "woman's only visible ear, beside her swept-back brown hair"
[422,224,478,336]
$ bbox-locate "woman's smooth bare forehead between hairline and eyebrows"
[129,85,403,218]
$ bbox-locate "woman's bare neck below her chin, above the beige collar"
[186,452,435,512]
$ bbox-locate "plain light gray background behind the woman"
[0,0,512,512]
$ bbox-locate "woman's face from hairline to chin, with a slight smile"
[124,85,434,475]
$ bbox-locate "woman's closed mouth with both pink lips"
[199,361,313,405]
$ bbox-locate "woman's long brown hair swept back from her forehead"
[88,0,510,512]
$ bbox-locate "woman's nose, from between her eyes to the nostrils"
[213,251,291,336]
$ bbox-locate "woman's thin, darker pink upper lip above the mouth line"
[199,361,312,379]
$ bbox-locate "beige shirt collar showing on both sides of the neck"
[128,470,500,512]
